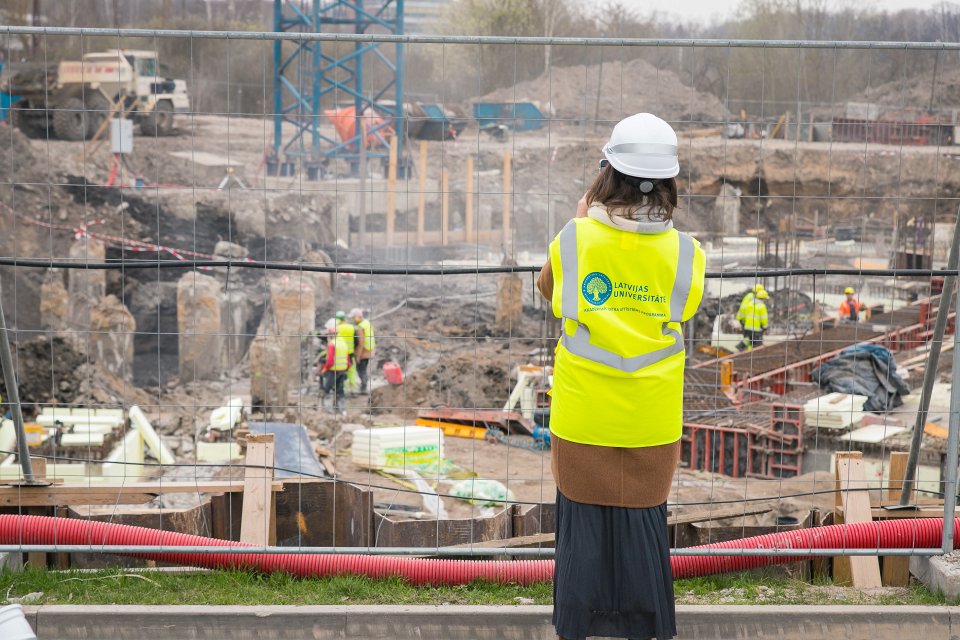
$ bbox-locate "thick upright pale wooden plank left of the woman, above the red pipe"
[240,433,277,547]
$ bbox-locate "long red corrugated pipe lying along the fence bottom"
[0,515,948,585]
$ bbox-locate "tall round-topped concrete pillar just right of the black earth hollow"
[177,271,223,382]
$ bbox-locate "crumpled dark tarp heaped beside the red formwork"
[810,344,910,413]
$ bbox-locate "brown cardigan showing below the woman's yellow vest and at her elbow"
[537,260,680,508]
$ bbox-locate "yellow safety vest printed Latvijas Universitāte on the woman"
[550,212,705,447]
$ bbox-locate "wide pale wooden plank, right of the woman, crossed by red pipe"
[834,451,881,589]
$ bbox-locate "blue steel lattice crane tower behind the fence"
[267,0,405,180]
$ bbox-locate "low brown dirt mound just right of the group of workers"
[370,353,511,418]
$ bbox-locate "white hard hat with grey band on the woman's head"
[603,113,680,180]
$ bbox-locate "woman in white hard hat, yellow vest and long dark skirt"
[537,113,705,638]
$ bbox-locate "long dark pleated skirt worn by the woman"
[553,491,677,640]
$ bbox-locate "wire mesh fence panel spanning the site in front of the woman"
[0,27,960,576]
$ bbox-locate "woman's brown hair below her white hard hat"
[587,164,677,220]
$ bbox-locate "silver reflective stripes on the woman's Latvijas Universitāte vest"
[560,220,694,373]
